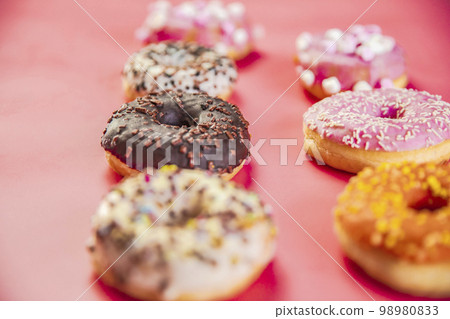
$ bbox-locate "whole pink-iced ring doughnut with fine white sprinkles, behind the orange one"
[303,88,450,173]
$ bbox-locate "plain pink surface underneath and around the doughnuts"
[0,0,450,300]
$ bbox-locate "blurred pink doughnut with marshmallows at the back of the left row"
[136,0,264,60]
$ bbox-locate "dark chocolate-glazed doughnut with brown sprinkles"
[101,91,250,178]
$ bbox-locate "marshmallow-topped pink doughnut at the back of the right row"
[295,25,408,99]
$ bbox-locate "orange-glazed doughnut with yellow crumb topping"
[334,163,450,297]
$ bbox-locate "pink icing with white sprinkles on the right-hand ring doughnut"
[303,89,450,152]
